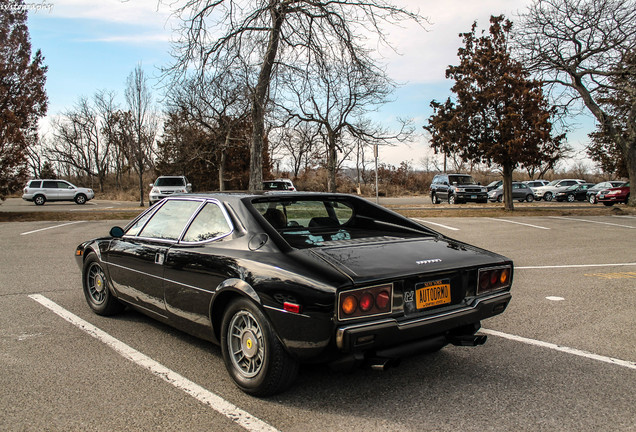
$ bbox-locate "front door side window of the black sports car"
[139,200,201,240]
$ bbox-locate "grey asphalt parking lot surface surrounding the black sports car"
[0,213,636,432]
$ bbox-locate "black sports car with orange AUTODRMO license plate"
[75,192,513,396]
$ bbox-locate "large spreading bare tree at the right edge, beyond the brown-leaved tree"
[518,0,636,206]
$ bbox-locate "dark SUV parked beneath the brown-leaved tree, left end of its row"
[431,174,488,204]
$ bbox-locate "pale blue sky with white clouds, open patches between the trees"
[25,0,594,169]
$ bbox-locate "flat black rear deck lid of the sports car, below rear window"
[311,238,504,282]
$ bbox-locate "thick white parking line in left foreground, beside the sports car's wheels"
[29,294,277,432]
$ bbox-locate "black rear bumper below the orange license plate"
[336,292,512,354]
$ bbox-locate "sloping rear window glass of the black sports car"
[251,197,434,249]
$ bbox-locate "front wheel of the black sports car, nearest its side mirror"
[82,253,124,316]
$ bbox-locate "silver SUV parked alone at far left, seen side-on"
[22,179,95,205]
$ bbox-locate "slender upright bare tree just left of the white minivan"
[125,65,158,207]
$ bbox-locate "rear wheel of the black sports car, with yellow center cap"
[221,298,298,396]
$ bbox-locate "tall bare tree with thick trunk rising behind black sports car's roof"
[172,0,423,190]
